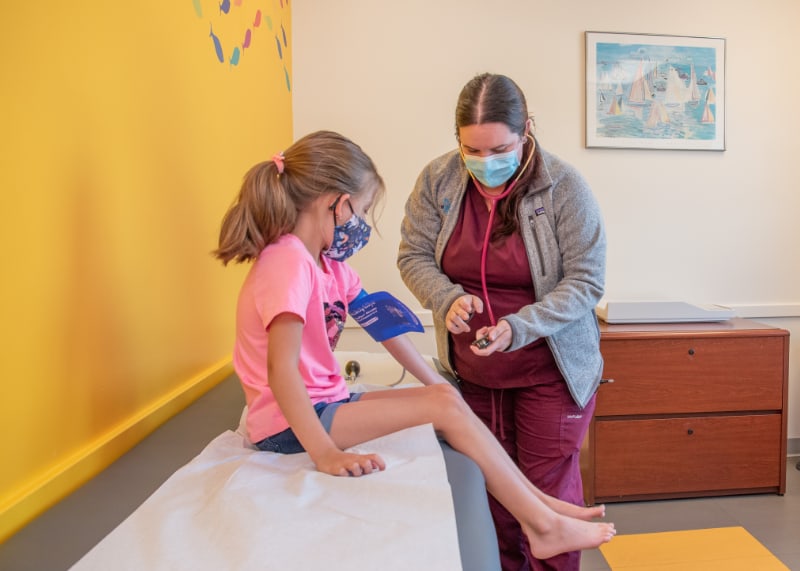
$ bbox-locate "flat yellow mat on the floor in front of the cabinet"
[600,527,789,571]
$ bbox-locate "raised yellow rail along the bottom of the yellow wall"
[0,358,233,543]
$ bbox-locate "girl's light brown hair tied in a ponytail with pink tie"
[213,131,384,265]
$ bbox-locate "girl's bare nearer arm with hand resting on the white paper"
[267,313,385,476]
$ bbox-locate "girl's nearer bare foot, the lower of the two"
[522,514,617,559]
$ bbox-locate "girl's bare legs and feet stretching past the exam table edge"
[331,385,615,559]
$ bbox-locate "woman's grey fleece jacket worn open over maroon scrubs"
[397,142,606,407]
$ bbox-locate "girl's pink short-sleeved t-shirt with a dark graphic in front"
[233,234,361,442]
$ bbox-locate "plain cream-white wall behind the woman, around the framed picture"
[292,0,800,438]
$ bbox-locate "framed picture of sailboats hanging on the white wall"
[586,32,725,151]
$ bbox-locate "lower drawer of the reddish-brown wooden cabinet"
[594,414,782,501]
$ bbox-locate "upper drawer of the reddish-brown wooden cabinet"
[595,336,785,416]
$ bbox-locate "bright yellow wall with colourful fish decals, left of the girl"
[0,0,292,541]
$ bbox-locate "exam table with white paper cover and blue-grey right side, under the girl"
[73,352,500,571]
